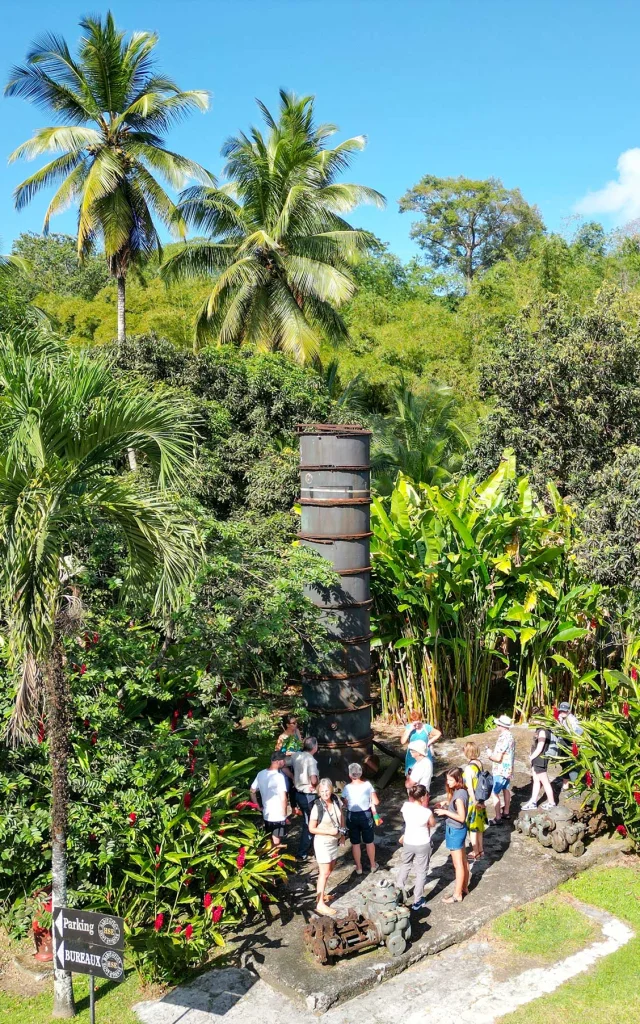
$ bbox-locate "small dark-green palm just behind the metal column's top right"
[371,380,469,495]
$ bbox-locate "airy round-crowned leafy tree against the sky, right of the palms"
[399,174,545,287]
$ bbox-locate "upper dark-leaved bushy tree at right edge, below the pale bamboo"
[468,291,640,501]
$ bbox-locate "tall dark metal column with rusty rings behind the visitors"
[298,423,373,774]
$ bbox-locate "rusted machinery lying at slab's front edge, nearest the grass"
[304,880,411,964]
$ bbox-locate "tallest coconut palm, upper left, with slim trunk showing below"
[4,12,213,341]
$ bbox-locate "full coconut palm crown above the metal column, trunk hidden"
[163,91,384,361]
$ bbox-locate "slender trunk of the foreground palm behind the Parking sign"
[45,636,76,1018]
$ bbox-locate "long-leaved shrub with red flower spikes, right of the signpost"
[80,761,289,982]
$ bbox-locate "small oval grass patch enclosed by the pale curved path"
[493,894,596,964]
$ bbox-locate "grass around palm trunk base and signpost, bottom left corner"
[0,973,153,1024]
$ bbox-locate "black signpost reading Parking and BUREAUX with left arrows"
[53,906,125,1024]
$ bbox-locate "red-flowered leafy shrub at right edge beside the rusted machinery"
[572,666,640,845]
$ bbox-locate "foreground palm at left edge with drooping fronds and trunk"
[0,328,197,1017]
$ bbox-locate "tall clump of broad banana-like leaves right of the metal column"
[372,453,597,735]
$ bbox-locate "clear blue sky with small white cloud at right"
[0,0,640,258]
